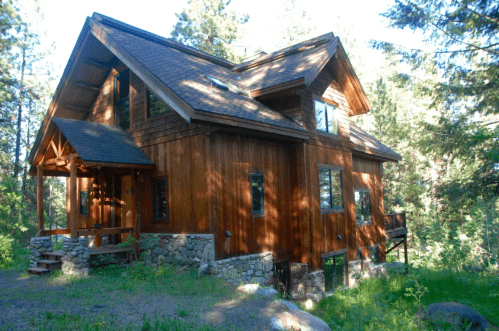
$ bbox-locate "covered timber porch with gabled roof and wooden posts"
[30,118,154,247]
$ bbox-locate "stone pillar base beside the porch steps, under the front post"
[62,238,90,276]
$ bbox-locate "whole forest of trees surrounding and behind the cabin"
[0,0,499,270]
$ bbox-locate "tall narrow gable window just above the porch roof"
[114,69,130,130]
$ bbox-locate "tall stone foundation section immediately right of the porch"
[140,233,215,266]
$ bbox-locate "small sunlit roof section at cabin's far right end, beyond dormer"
[350,123,402,161]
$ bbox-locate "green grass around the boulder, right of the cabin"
[312,268,499,331]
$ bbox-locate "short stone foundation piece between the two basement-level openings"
[290,263,326,301]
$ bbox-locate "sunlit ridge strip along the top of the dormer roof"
[232,32,334,72]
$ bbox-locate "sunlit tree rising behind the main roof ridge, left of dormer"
[171,0,248,61]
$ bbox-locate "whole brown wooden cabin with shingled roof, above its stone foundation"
[30,14,407,286]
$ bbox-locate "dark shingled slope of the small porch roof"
[53,117,154,166]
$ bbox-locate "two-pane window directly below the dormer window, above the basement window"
[319,168,343,210]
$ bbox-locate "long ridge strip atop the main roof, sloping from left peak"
[92,12,234,68]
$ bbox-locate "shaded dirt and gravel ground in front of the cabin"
[0,271,288,330]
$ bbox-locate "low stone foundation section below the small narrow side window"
[210,252,274,285]
